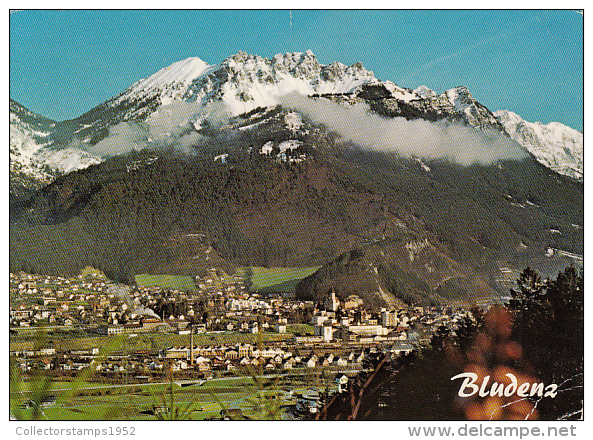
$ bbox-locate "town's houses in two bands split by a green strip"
[10,269,466,384]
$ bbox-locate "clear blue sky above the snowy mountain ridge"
[10,10,583,130]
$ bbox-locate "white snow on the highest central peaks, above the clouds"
[111,50,376,120]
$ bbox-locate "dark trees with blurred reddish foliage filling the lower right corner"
[318,266,584,420]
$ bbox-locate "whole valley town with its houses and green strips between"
[10,267,470,419]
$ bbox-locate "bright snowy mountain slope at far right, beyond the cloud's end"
[494,110,583,180]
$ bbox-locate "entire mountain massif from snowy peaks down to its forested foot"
[10,51,583,307]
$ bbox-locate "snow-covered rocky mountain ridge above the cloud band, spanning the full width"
[10,51,582,192]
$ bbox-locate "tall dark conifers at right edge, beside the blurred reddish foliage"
[507,266,584,420]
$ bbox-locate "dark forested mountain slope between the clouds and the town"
[10,133,583,306]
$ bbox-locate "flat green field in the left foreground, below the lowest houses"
[10,374,333,420]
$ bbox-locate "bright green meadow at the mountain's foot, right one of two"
[242,266,321,293]
